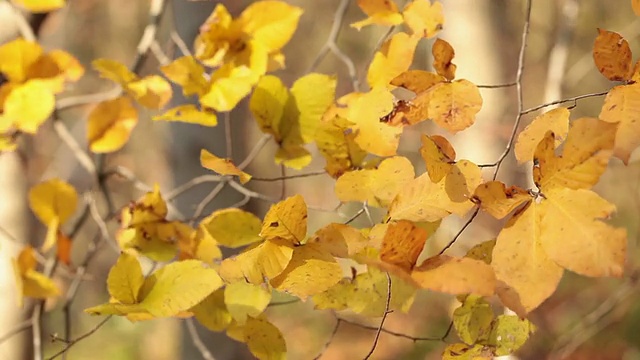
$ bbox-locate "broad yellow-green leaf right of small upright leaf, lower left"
[140,260,223,317]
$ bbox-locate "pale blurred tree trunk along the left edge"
[0,2,29,359]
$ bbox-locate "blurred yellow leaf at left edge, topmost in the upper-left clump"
[0,38,43,83]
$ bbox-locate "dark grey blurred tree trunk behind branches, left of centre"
[169,0,253,360]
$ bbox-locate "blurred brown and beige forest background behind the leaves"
[0,0,640,360]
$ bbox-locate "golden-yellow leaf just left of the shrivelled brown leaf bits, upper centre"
[347,88,402,156]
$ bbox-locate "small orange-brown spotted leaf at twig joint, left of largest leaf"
[473,181,532,219]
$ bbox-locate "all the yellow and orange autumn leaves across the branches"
[5,0,640,359]
